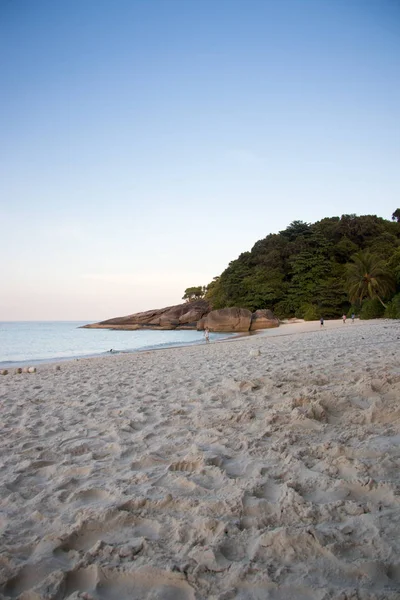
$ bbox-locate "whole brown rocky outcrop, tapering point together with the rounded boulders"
[84,300,279,333]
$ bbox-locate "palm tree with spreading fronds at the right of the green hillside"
[347,250,395,308]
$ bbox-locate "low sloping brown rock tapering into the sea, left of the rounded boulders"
[84,300,211,329]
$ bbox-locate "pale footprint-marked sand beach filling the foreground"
[0,321,400,600]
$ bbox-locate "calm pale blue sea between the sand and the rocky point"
[0,321,234,367]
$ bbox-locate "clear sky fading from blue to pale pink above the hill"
[0,0,400,321]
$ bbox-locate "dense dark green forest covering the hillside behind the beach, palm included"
[184,214,400,320]
